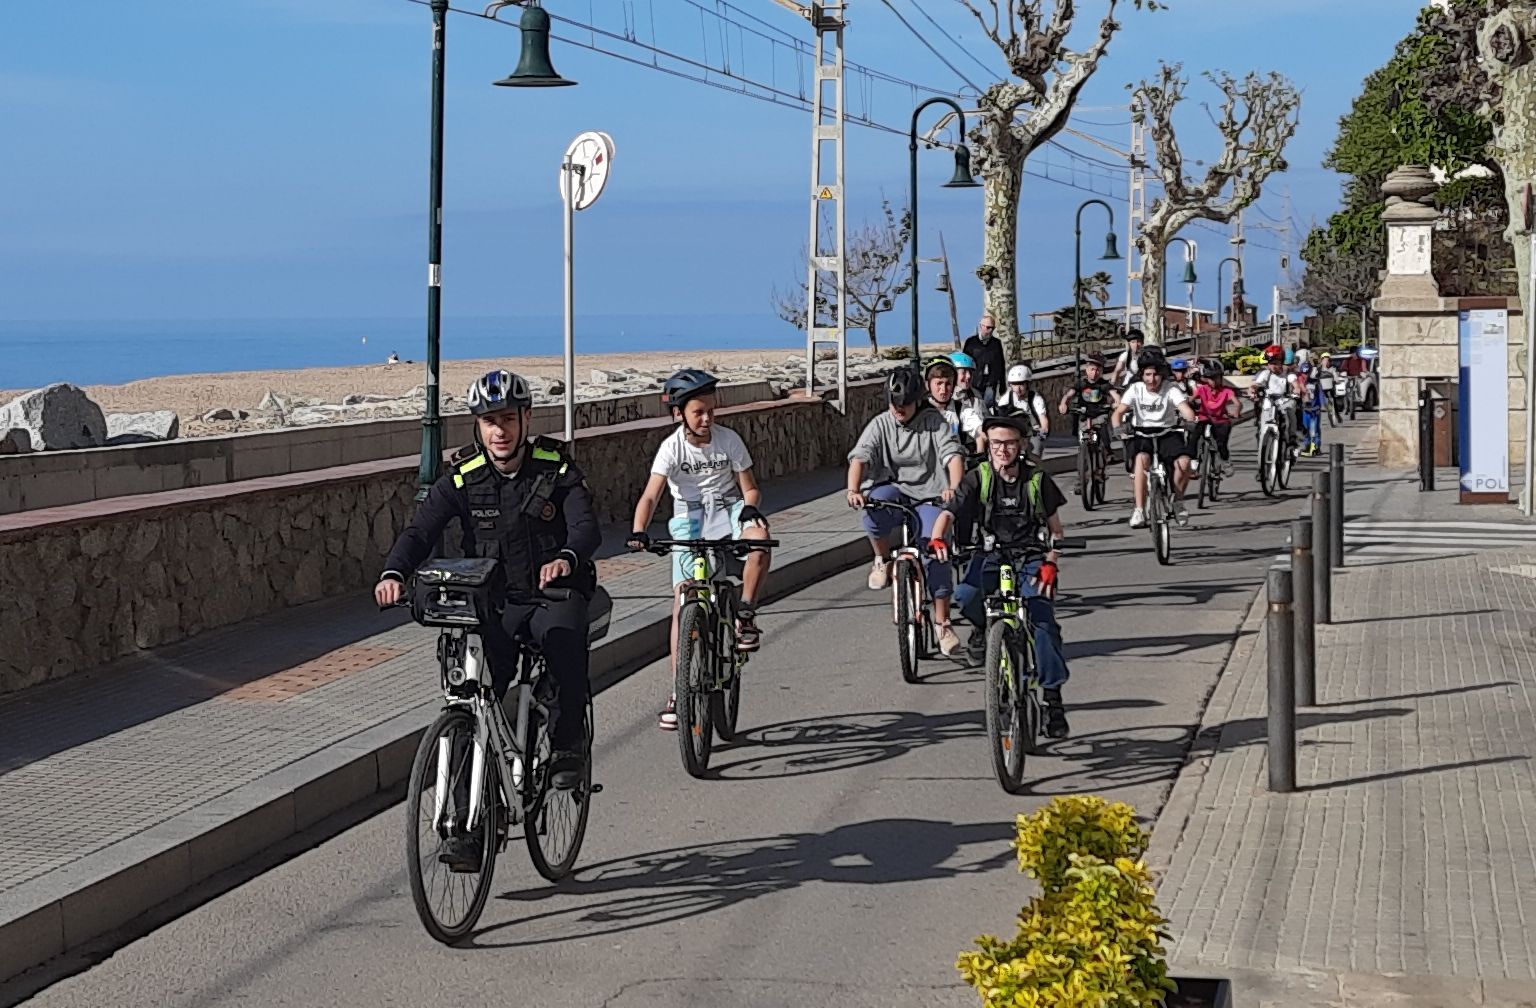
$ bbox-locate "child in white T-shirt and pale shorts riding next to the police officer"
[627,367,768,731]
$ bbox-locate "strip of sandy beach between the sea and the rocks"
[0,347,890,419]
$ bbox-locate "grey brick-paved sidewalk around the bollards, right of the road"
[1149,549,1536,1008]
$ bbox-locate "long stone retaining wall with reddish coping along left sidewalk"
[0,381,885,693]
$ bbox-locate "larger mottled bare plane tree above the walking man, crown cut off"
[958,0,1161,358]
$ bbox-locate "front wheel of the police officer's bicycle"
[406,708,499,945]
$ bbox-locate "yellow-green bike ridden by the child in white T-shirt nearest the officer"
[647,538,779,778]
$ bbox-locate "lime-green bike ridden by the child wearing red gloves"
[972,536,1087,794]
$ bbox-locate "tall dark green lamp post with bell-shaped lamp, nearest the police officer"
[416,0,576,501]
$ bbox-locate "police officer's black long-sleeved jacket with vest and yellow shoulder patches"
[384,438,602,595]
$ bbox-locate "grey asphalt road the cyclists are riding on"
[31,427,1345,1008]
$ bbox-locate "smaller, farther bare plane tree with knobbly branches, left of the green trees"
[1134,63,1301,343]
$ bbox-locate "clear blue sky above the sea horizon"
[0,0,1415,338]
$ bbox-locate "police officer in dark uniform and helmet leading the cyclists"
[373,370,602,817]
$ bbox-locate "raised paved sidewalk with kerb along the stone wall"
[0,479,909,982]
